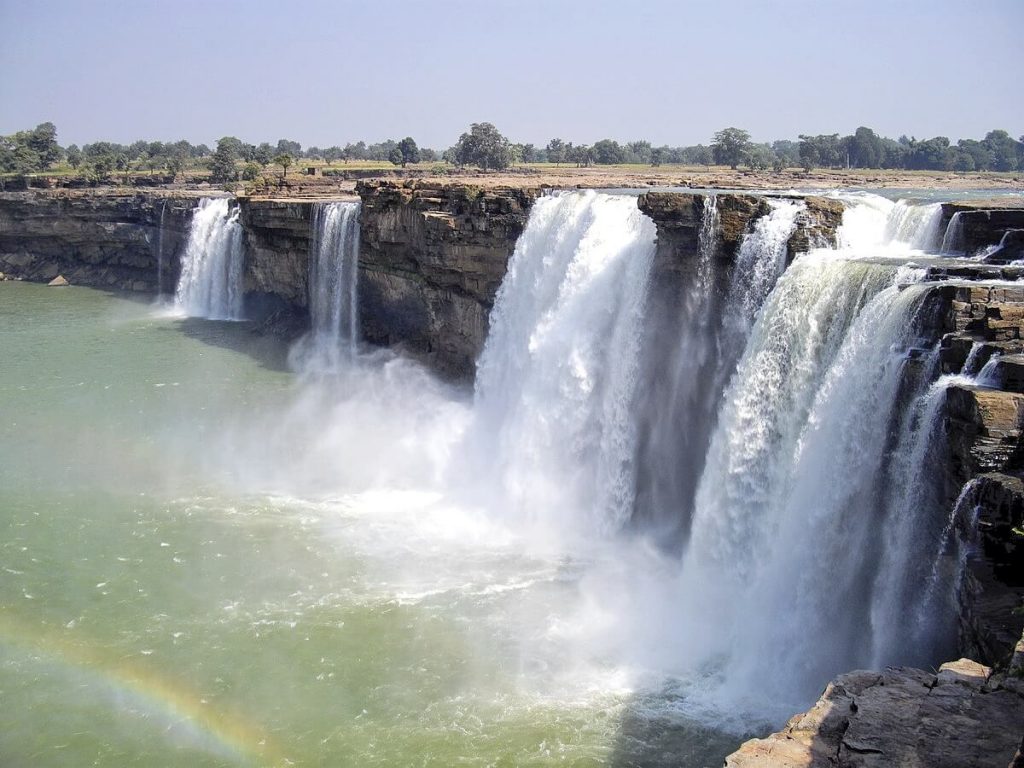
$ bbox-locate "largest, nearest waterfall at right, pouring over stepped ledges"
[663,252,950,702]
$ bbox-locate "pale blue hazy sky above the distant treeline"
[0,0,1024,148]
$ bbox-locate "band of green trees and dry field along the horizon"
[0,123,1024,183]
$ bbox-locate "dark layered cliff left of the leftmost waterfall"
[0,191,196,293]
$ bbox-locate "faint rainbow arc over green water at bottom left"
[0,610,291,766]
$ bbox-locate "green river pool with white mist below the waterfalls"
[0,283,741,766]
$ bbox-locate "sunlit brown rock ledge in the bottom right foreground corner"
[725,658,1024,768]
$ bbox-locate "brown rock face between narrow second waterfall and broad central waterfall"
[358,181,541,378]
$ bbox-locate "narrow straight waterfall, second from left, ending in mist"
[301,202,359,369]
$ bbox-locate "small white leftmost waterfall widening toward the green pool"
[174,198,244,319]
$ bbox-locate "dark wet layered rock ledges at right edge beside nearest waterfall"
[913,280,1024,664]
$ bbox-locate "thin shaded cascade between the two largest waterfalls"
[636,197,805,541]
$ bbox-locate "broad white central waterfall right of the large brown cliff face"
[469,191,655,534]
